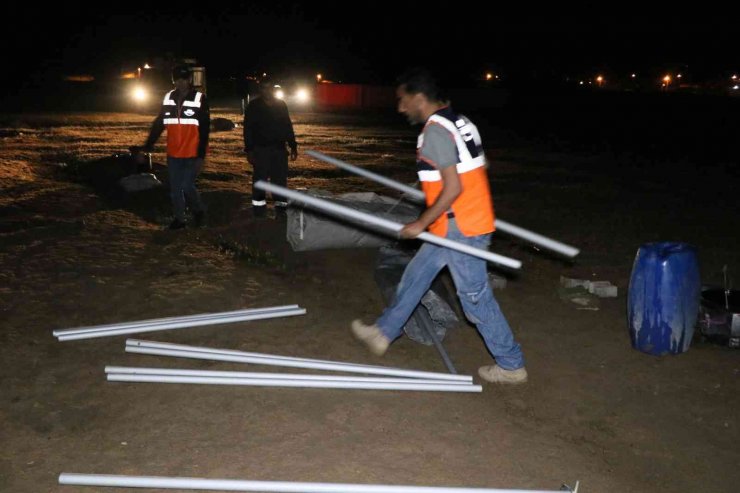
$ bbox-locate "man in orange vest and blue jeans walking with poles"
[352,69,527,384]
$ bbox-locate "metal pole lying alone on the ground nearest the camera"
[59,472,577,493]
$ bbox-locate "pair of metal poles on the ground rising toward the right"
[53,305,306,341]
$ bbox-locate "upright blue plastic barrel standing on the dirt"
[627,242,701,356]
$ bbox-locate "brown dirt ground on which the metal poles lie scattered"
[0,109,740,492]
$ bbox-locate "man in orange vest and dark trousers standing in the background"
[143,65,211,229]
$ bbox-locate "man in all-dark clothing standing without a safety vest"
[244,80,298,216]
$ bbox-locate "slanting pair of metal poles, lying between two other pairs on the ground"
[120,339,473,385]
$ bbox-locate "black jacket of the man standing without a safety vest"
[244,96,298,152]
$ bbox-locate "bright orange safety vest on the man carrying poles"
[416,107,496,237]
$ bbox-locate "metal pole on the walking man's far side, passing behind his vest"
[306,151,580,258]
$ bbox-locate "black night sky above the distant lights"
[2,5,740,87]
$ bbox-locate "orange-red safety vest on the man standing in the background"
[162,90,203,158]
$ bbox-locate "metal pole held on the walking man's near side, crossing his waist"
[254,181,522,269]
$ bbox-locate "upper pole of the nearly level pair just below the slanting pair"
[105,366,470,385]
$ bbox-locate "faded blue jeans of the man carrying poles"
[375,228,524,370]
